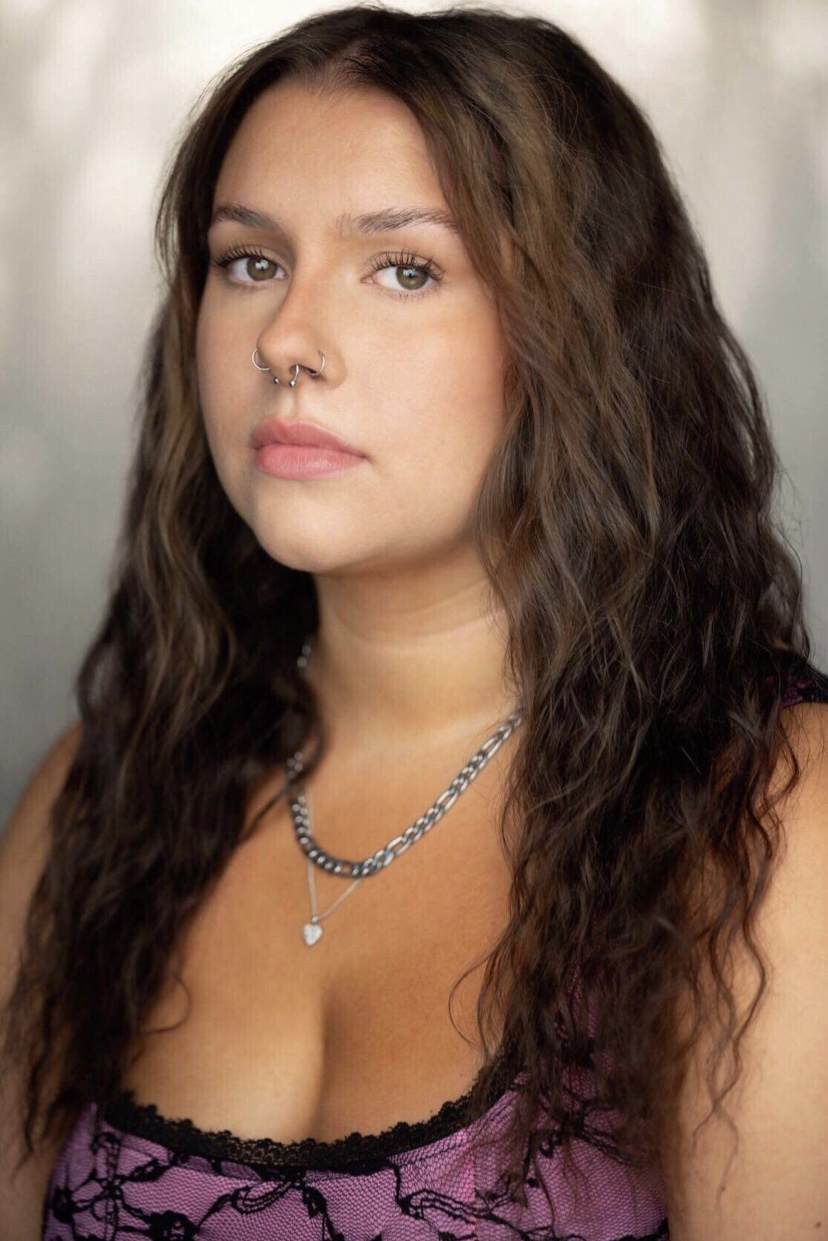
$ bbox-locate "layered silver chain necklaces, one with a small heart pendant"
[286,638,523,948]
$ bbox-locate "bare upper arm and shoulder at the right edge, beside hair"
[667,702,828,1241]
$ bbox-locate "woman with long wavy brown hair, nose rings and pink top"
[2,7,828,1241]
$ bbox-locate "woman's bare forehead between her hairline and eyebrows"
[216,82,444,211]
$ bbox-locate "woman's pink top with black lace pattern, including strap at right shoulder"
[42,665,828,1241]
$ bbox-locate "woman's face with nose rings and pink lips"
[197,82,505,573]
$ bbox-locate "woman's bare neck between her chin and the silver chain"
[301,558,518,753]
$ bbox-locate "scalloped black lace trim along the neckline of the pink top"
[101,1060,513,1174]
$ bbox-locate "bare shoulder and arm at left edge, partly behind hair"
[0,725,81,1241]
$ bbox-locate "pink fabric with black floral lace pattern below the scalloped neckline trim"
[43,1092,669,1241]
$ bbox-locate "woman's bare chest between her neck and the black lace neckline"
[123,744,509,1142]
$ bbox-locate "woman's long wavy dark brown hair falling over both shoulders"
[5,4,811,1201]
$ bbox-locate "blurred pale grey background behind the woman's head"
[0,0,828,820]
